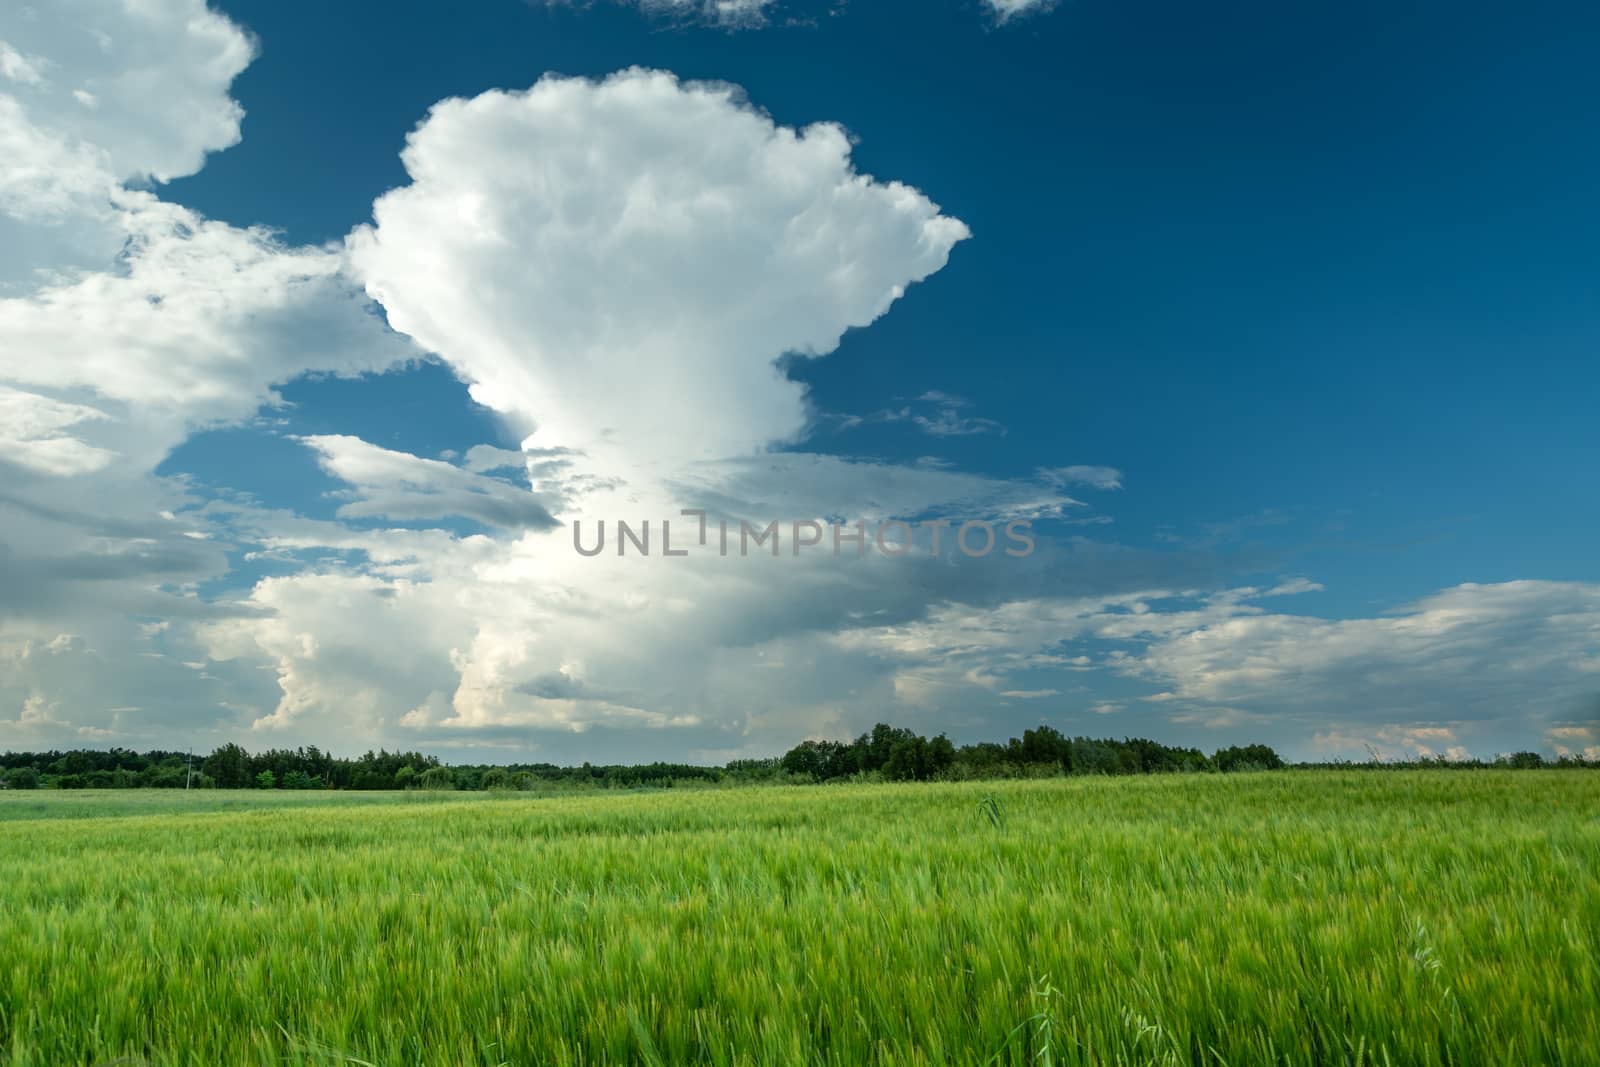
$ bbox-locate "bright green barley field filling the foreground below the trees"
[0,771,1600,1067]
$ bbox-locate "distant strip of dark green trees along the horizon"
[0,723,1580,790]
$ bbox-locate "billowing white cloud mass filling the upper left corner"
[0,0,414,474]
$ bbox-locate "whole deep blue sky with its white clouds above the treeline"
[0,0,1600,761]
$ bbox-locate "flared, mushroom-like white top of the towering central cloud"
[350,70,968,472]
